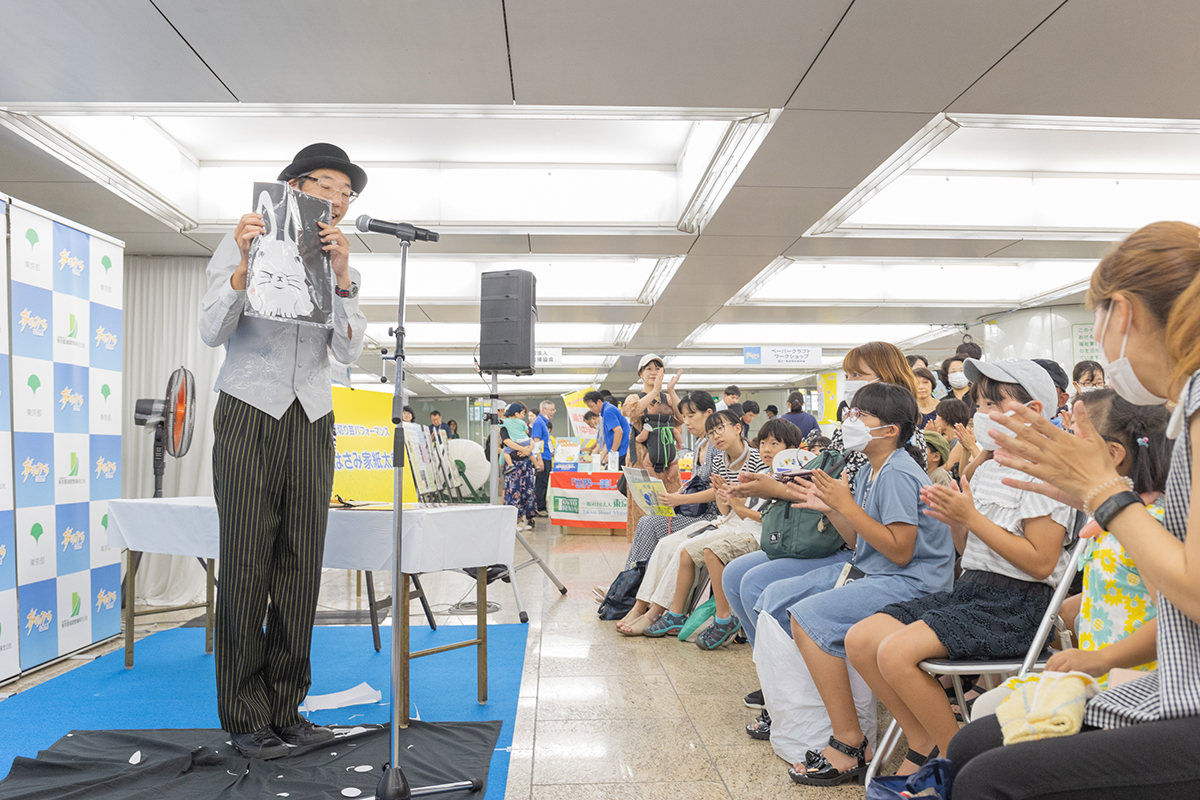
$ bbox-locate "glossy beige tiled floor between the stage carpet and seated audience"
[2,522,902,800]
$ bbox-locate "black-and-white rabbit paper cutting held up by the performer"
[246,182,334,327]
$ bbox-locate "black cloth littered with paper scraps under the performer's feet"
[0,721,500,800]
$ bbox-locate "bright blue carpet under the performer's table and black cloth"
[0,625,527,800]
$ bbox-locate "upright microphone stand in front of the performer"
[376,228,484,800]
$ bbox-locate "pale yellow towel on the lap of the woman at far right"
[996,672,1100,745]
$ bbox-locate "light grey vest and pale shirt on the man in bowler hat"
[200,234,367,422]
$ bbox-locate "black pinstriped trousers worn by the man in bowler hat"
[212,392,334,733]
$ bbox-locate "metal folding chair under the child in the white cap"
[864,539,1091,784]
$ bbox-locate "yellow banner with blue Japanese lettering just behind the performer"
[334,386,418,503]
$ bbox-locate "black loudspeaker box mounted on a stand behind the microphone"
[479,270,538,375]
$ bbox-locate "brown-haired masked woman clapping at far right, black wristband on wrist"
[948,222,1200,800]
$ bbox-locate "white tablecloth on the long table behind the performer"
[108,497,517,573]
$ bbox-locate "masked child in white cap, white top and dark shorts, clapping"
[846,359,1074,774]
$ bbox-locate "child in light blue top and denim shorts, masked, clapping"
[760,383,954,786]
